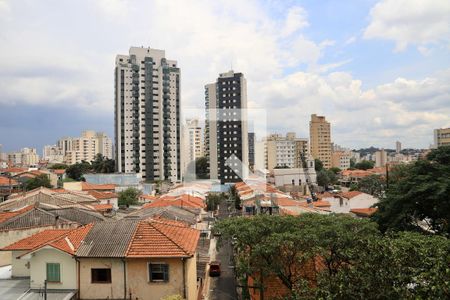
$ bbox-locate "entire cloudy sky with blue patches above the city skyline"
[0,0,450,152]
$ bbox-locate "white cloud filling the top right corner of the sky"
[364,0,450,53]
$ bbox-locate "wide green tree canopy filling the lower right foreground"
[215,214,450,299]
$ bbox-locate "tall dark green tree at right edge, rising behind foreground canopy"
[373,147,450,235]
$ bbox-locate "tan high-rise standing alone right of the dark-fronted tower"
[309,114,332,169]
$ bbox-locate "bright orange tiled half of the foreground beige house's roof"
[126,219,200,257]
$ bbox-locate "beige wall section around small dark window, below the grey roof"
[80,258,125,299]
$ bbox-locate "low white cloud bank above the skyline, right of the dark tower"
[259,70,450,148]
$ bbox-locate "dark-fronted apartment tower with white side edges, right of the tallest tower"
[205,71,248,183]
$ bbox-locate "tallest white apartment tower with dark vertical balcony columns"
[115,47,181,182]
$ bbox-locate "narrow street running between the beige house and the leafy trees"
[209,201,238,300]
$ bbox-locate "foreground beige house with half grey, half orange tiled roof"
[76,219,199,300]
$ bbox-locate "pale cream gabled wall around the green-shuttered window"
[30,249,77,289]
